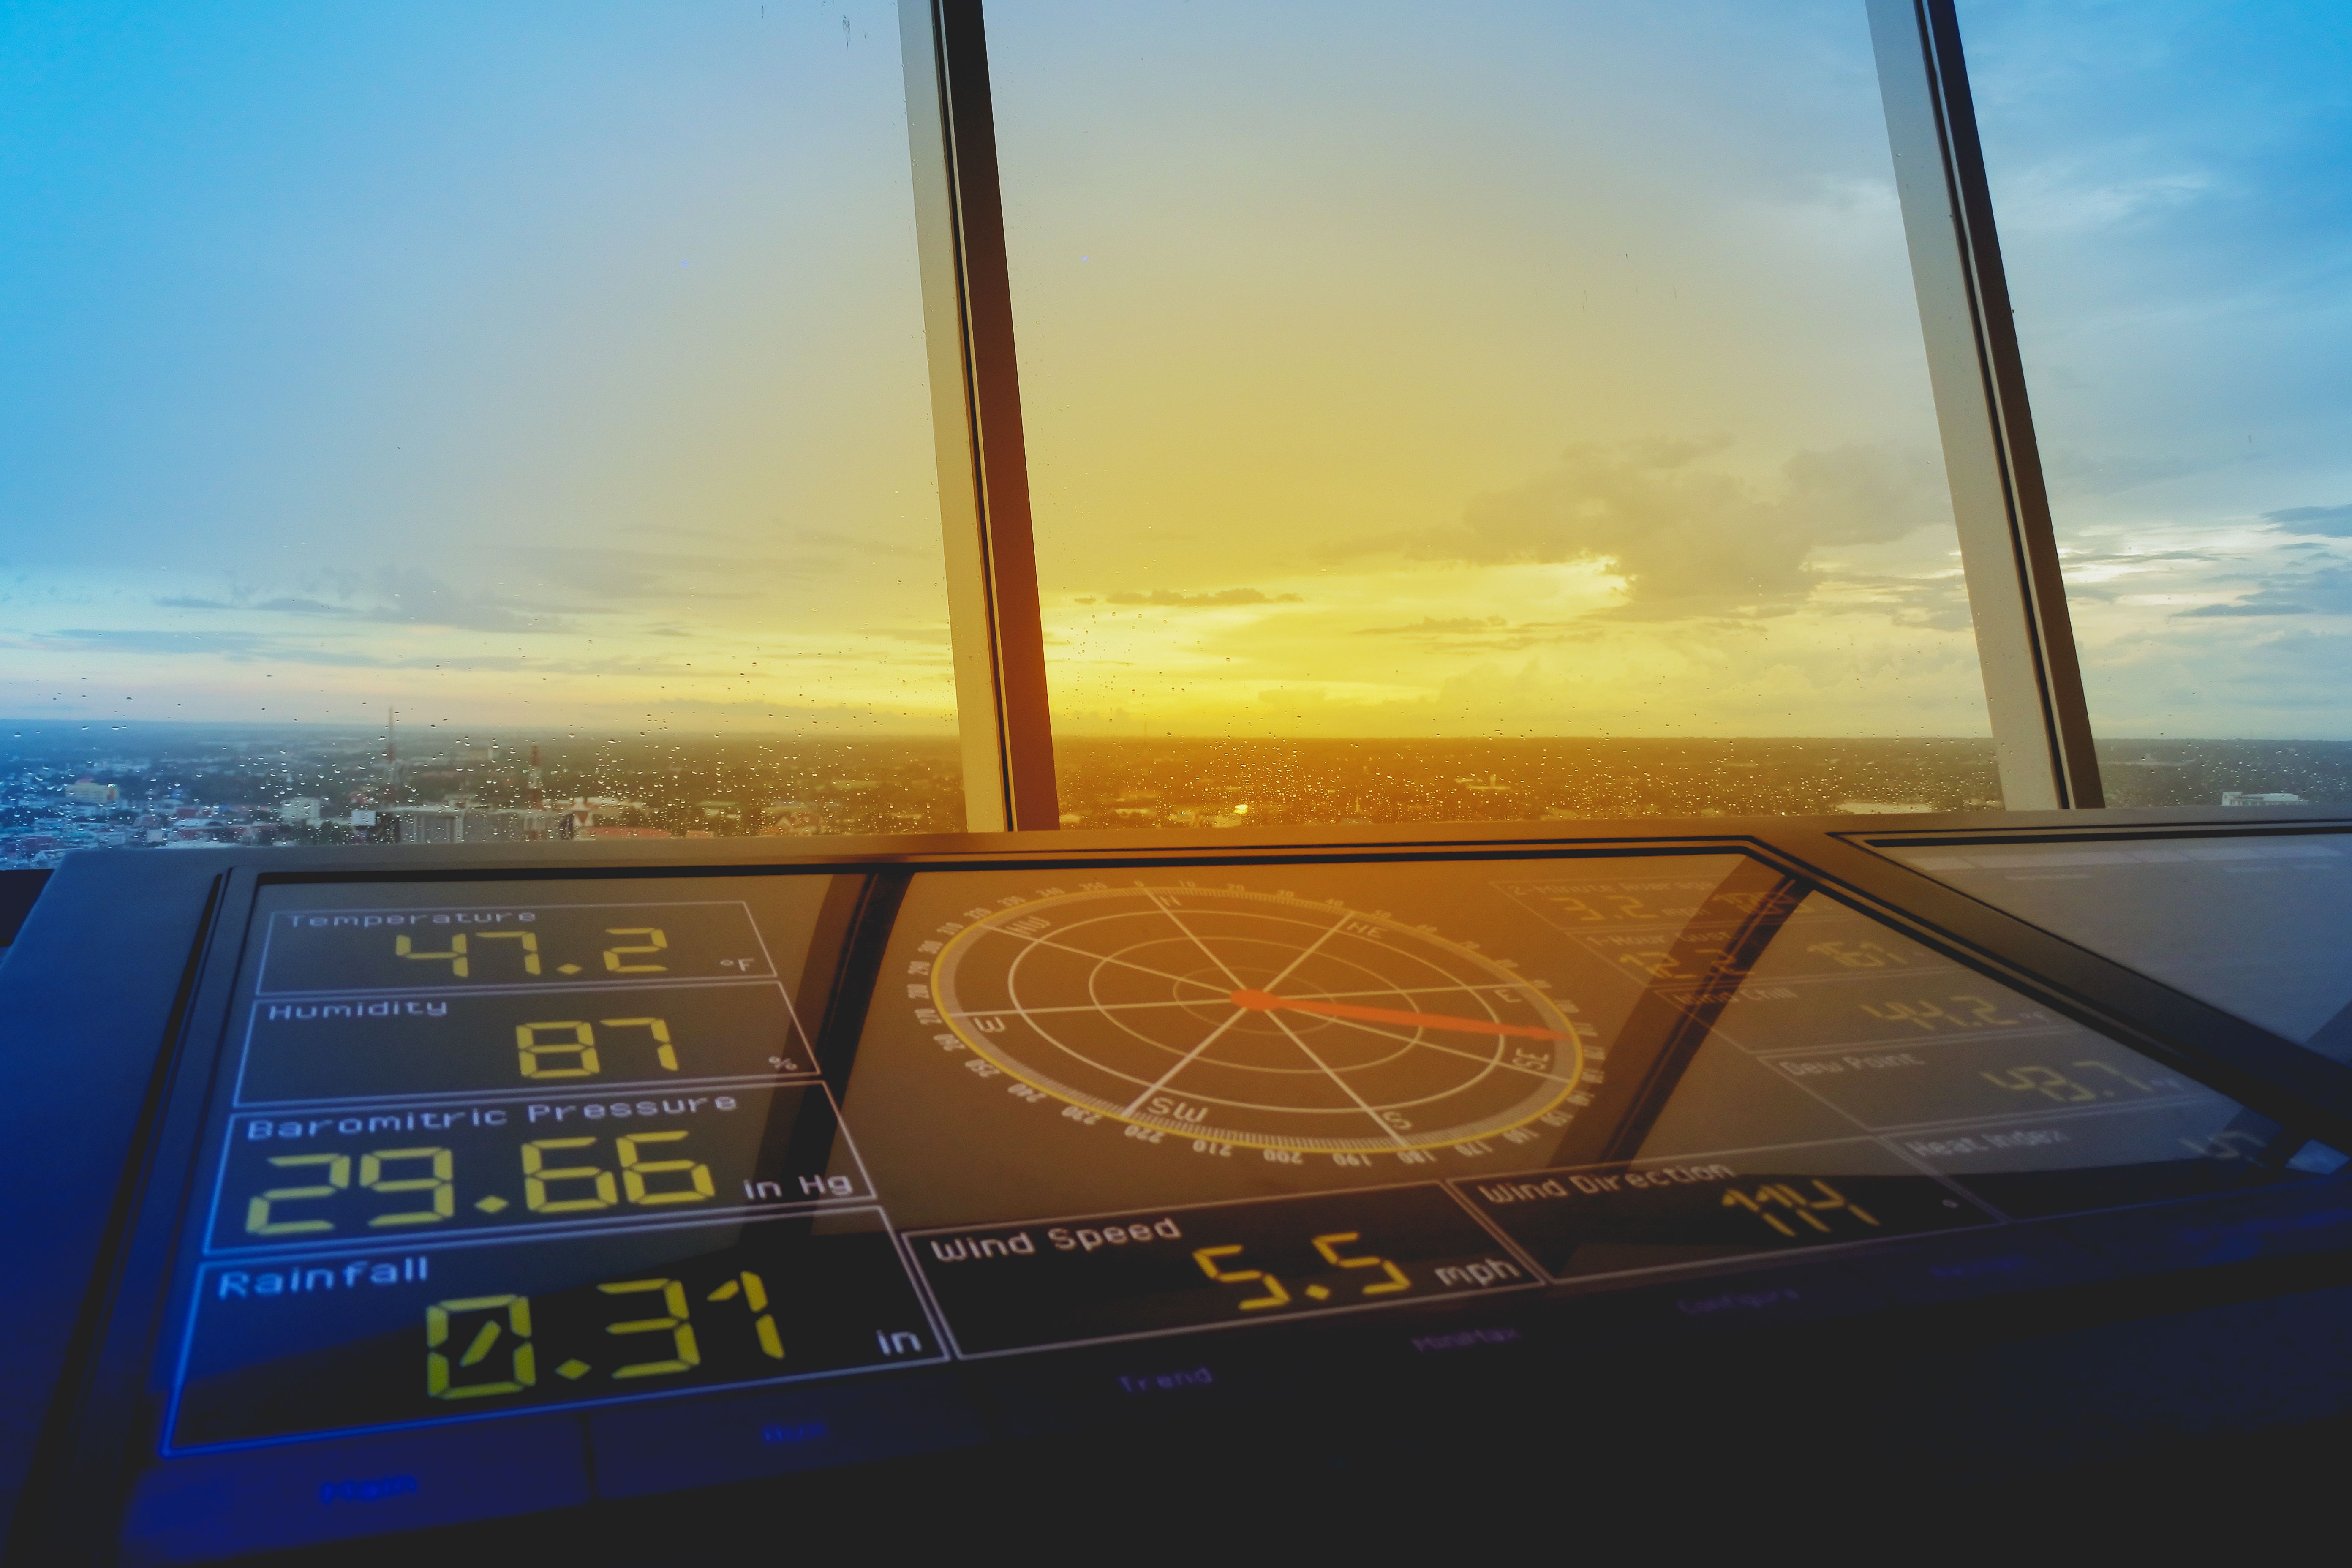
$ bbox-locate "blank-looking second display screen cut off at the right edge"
[1877,832,2352,1062]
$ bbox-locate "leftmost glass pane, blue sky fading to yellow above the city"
[0,0,962,863]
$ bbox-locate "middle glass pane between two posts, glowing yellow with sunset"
[988,0,1997,825]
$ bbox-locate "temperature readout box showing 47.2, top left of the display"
[259,900,776,994]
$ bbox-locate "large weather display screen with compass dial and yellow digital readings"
[125,853,2293,1561]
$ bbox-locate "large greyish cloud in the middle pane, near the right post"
[1369,440,1950,618]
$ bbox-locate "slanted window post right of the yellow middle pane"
[1867,0,2105,808]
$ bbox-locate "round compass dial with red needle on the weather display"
[931,884,1585,1157]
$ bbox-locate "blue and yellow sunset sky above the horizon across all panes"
[0,0,2352,738]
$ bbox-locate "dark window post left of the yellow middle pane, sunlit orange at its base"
[898,0,1061,832]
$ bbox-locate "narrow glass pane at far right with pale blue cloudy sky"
[1959,0,2352,806]
